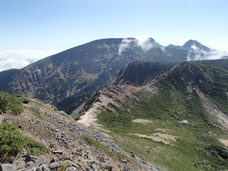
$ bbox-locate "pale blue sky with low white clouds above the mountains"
[0,0,228,71]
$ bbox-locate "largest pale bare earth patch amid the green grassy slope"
[132,133,177,145]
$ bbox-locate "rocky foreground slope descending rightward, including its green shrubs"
[0,92,166,171]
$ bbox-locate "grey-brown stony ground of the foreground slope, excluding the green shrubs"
[0,99,165,171]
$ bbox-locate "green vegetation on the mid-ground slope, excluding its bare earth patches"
[98,64,228,170]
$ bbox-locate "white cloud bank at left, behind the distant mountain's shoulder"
[0,50,60,71]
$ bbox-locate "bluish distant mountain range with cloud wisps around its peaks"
[0,38,226,113]
